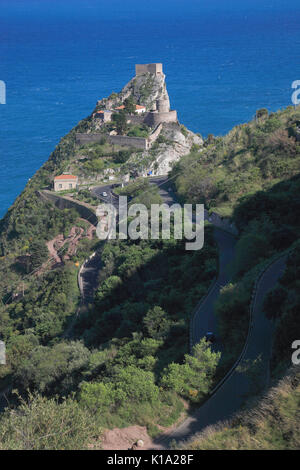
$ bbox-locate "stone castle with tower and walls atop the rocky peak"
[76,63,178,149]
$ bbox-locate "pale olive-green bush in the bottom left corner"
[0,394,101,450]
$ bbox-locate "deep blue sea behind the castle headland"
[0,0,300,217]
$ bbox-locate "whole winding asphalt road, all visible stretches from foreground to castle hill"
[92,177,286,448]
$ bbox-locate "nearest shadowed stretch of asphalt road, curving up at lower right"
[157,258,286,447]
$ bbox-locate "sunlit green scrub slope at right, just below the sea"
[172,107,300,216]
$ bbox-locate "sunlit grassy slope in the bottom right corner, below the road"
[183,368,300,450]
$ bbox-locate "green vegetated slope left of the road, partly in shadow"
[0,114,219,440]
